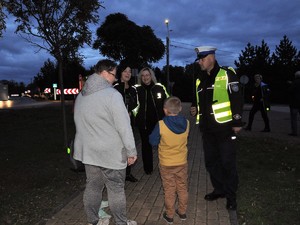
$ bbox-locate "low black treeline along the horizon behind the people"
[3,36,300,104]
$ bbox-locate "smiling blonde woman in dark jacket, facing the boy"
[135,67,169,175]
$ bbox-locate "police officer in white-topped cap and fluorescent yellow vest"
[190,46,242,210]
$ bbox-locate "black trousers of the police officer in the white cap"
[202,128,238,199]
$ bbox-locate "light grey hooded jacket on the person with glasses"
[74,73,137,169]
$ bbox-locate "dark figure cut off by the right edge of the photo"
[288,71,300,136]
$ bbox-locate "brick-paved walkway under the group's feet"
[47,103,299,225]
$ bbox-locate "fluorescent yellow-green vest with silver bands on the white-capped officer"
[196,68,232,124]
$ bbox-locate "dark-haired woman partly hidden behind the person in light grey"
[114,63,138,182]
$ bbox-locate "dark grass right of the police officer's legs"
[238,134,300,225]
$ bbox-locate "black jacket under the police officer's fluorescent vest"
[192,62,243,132]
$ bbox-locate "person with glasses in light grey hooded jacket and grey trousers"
[74,60,137,225]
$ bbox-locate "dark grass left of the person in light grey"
[0,106,85,225]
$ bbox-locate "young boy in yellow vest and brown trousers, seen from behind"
[149,96,189,224]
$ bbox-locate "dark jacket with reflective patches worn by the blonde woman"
[135,82,168,132]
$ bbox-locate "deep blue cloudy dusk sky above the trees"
[0,0,300,84]
